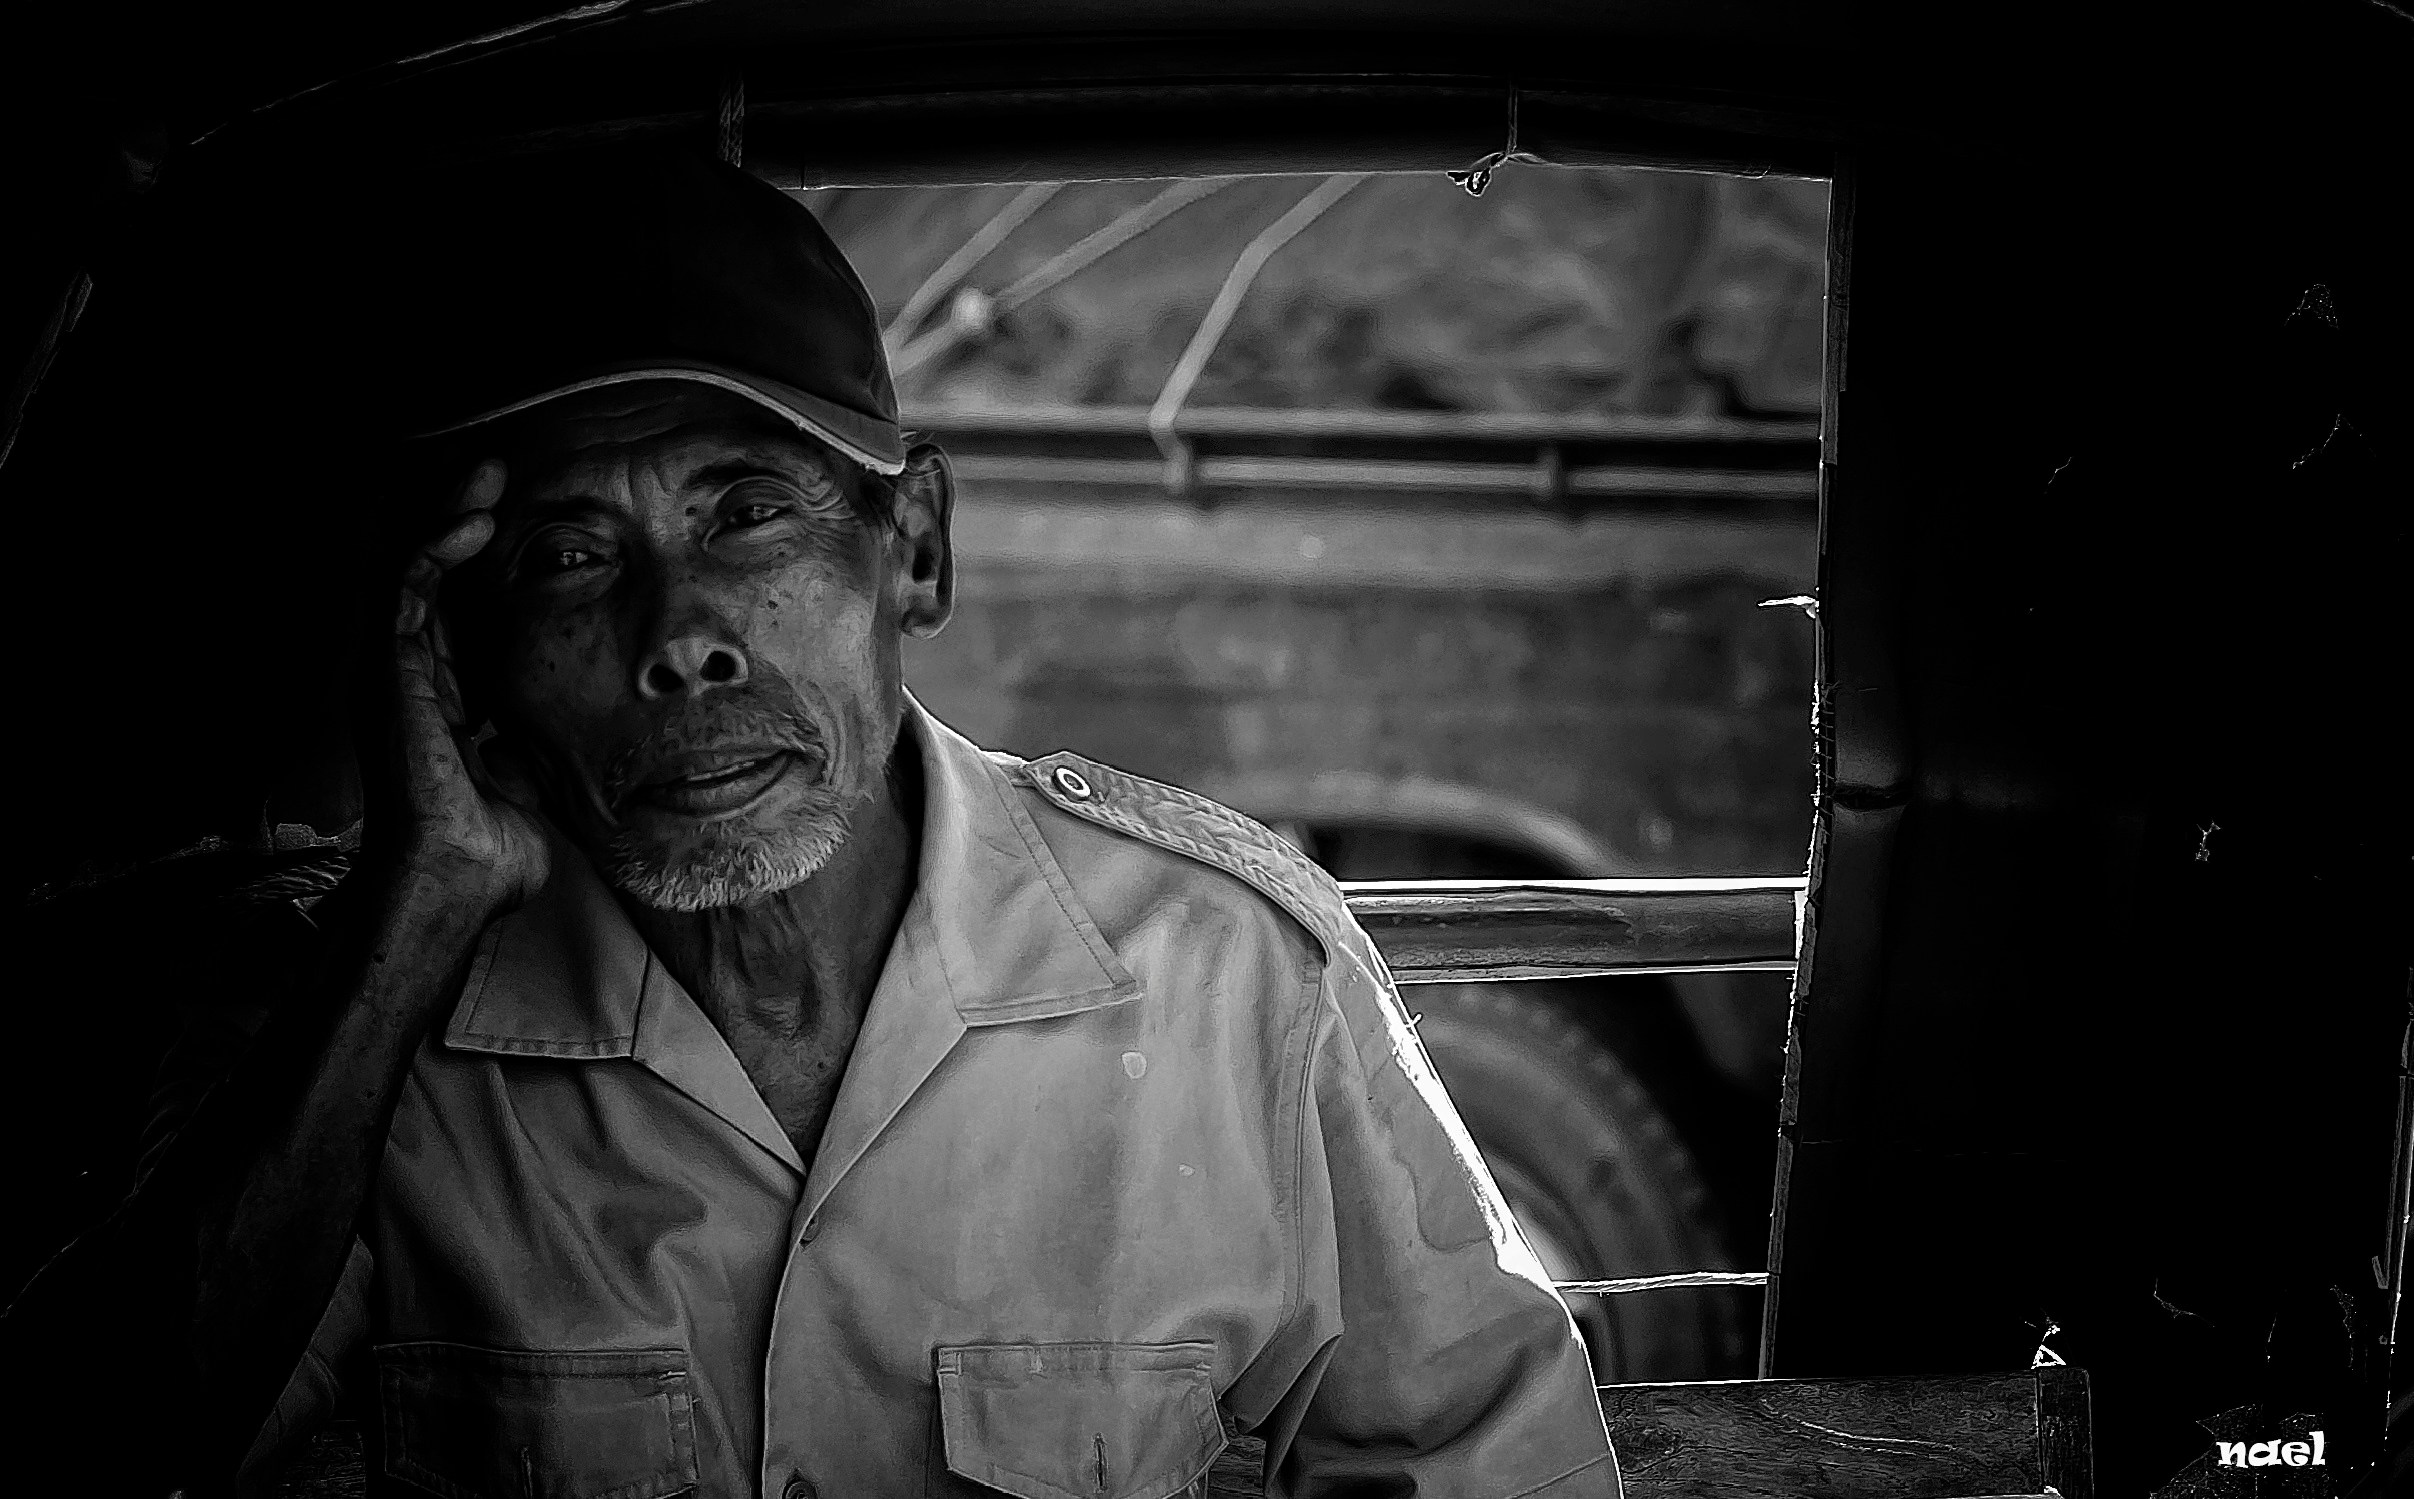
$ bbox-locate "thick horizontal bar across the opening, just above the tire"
[1342,876,1811,985]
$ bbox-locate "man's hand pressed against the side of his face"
[393,459,548,922]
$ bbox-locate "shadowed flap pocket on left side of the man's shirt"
[374,1342,695,1499]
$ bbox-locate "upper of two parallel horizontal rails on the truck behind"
[903,406,1818,444]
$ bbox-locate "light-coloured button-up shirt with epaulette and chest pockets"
[280,707,1620,1499]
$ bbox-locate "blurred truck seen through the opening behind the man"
[806,164,1827,1381]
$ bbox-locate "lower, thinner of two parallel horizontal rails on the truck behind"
[954,454,1818,500]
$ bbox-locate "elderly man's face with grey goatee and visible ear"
[466,381,951,910]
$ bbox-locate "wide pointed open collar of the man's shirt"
[444,695,1139,1060]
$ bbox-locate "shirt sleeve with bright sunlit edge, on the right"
[1258,944,1620,1499]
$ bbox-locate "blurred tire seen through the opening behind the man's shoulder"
[1400,982,1755,1383]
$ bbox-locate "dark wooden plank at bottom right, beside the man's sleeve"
[1600,1371,2076,1499]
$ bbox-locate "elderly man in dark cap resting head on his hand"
[4,162,1620,1499]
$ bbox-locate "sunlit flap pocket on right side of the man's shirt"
[932,1342,1224,1499]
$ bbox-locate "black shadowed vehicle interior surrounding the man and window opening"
[0,0,2414,1499]
